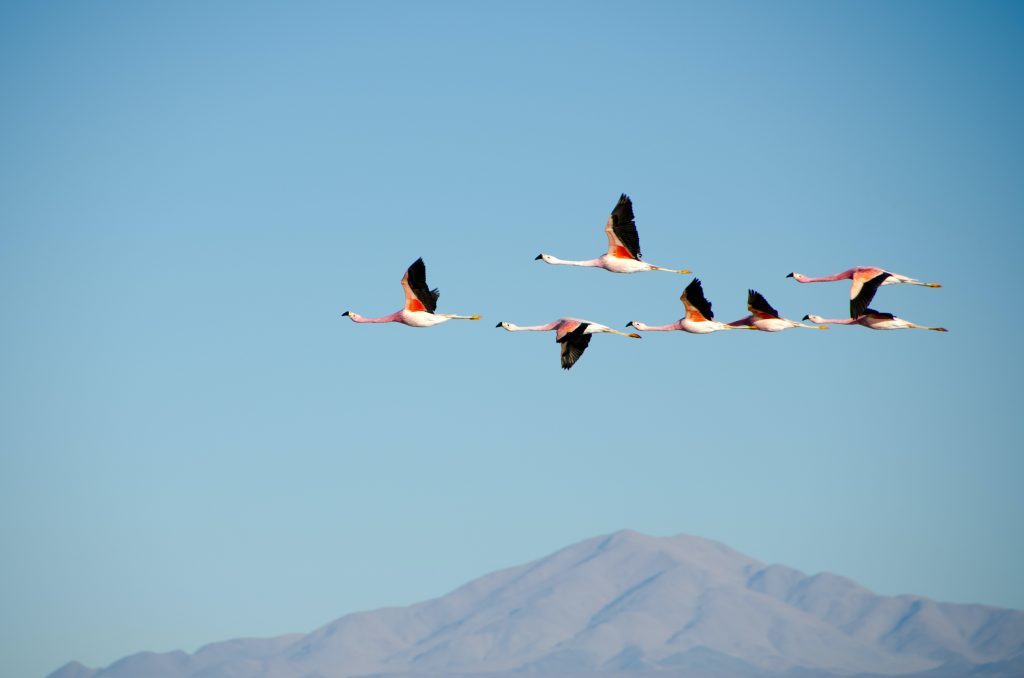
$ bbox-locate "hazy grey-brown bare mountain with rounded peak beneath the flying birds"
[49,531,1024,678]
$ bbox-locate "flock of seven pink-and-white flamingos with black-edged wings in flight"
[342,194,947,370]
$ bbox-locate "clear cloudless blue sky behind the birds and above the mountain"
[0,2,1024,676]
